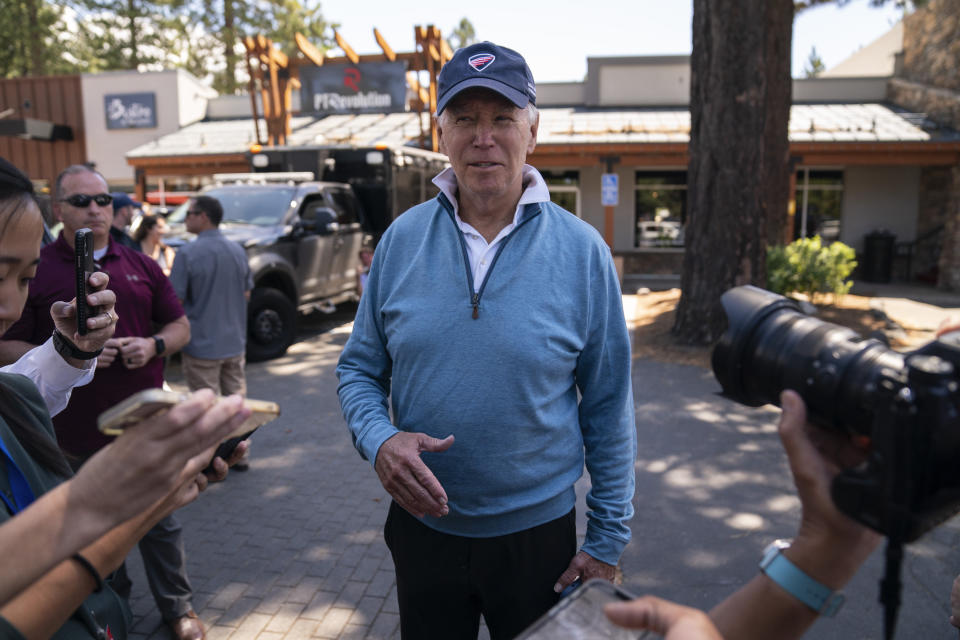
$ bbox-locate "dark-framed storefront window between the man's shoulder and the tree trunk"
[633,171,687,248]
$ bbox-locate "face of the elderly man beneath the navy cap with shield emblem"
[438,88,539,205]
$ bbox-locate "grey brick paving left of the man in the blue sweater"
[128,331,408,640]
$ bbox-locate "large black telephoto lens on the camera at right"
[712,286,904,435]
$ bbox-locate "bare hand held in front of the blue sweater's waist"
[373,431,453,518]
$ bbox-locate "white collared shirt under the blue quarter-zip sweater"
[433,164,550,292]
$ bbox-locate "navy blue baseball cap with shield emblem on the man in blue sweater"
[437,42,537,115]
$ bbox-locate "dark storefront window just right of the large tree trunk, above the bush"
[793,169,843,244]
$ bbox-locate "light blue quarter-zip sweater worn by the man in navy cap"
[337,194,636,564]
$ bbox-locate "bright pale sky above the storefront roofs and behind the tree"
[321,0,901,82]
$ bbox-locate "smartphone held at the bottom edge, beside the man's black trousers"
[516,578,659,640]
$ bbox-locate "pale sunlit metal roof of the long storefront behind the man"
[126,103,960,158]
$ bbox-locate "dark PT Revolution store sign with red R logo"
[300,62,407,115]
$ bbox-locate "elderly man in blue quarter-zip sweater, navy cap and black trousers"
[337,42,636,639]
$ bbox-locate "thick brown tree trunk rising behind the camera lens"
[673,0,793,344]
